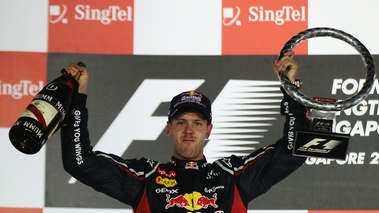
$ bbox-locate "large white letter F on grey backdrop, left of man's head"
[94,79,204,155]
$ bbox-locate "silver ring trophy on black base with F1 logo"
[278,27,376,159]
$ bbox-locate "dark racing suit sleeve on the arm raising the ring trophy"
[235,88,310,205]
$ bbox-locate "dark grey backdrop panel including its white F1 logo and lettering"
[46,54,378,209]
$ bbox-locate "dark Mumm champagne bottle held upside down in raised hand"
[9,62,85,154]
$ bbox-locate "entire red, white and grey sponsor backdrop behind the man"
[0,0,379,213]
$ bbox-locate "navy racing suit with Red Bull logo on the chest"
[61,87,309,213]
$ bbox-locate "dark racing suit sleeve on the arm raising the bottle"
[61,94,146,207]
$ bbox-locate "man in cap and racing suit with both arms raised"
[61,51,309,213]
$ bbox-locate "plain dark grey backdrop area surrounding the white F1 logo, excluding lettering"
[45,53,379,209]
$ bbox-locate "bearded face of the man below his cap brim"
[166,112,212,160]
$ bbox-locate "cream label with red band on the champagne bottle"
[21,100,58,128]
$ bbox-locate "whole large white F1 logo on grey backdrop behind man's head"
[69,79,282,183]
